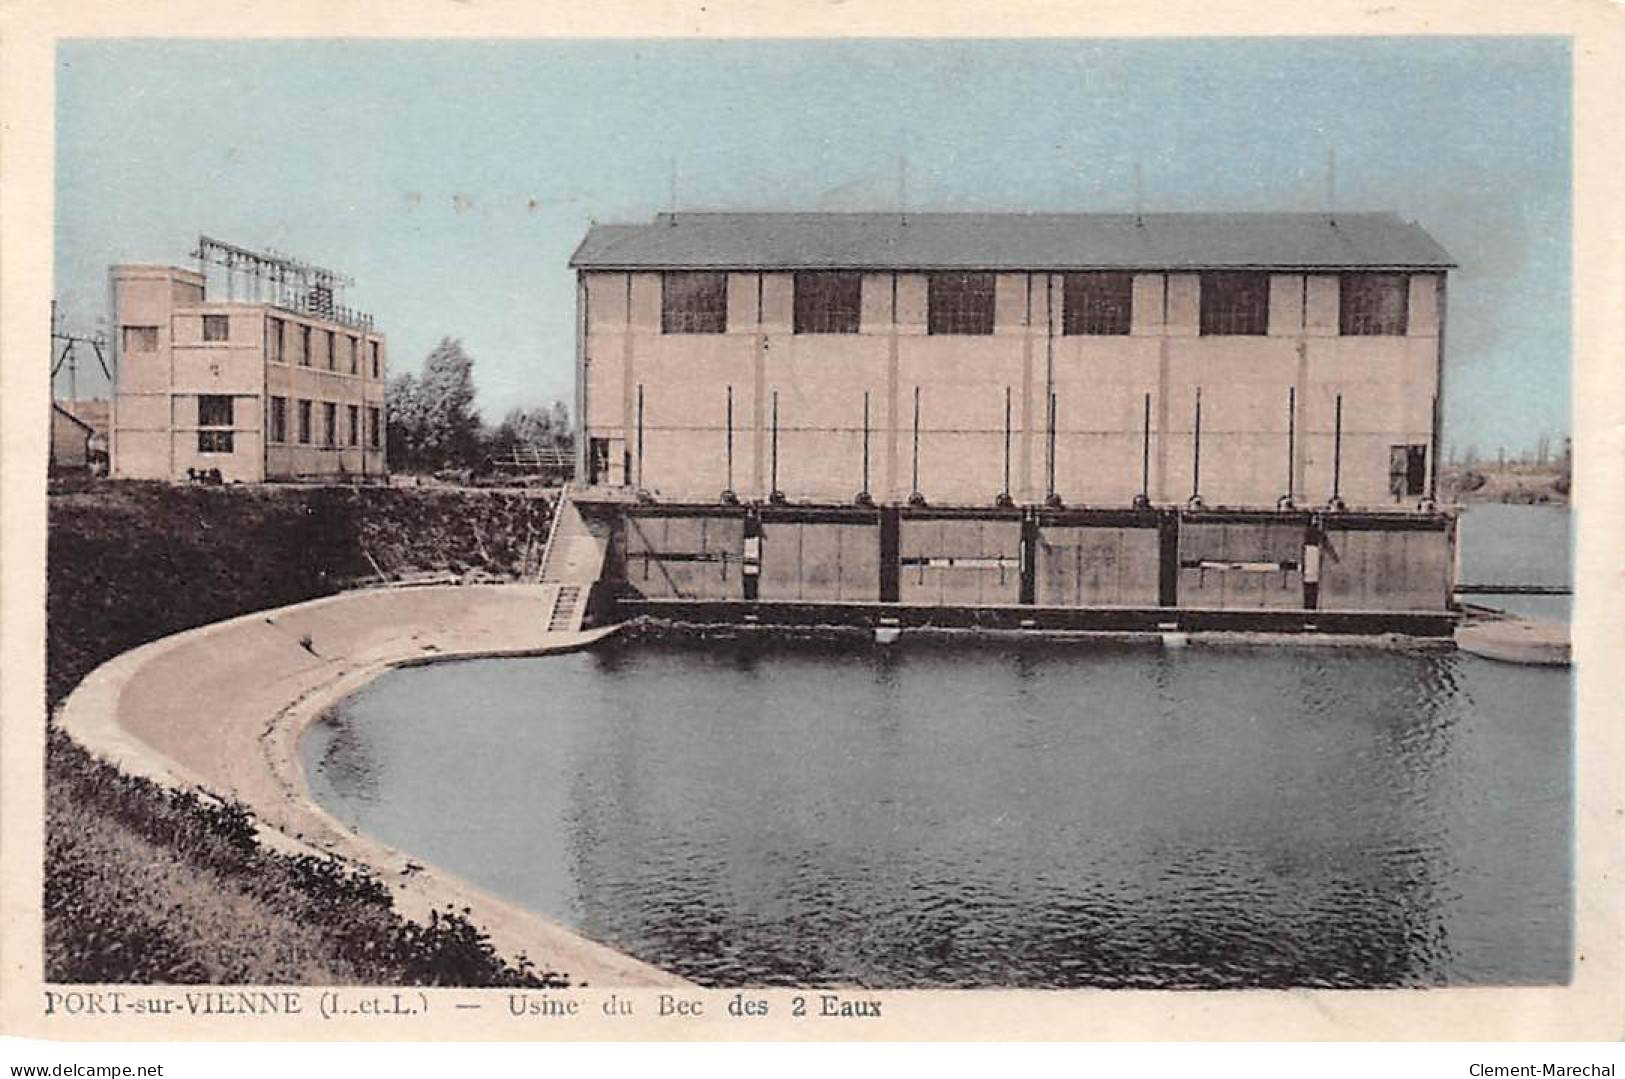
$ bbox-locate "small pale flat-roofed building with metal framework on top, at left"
[111,237,388,483]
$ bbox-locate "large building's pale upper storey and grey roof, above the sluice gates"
[570,213,1454,509]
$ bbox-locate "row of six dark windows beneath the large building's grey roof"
[660,270,1411,336]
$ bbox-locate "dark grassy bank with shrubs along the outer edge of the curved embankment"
[46,483,564,985]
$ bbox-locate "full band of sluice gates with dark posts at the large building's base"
[574,492,1458,637]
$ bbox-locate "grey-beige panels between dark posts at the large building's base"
[606,505,1456,611]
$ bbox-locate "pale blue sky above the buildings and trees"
[55,37,1570,453]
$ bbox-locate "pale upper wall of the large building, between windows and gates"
[580,271,1443,509]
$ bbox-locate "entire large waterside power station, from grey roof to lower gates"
[541,213,1456,637]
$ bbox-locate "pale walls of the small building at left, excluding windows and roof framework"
[111,267,388,483]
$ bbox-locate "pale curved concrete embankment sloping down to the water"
[59,585,684,986]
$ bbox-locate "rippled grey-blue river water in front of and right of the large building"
[302,507,1571,988]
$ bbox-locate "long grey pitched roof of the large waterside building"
[570,213,1456,270]
